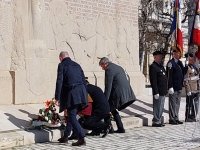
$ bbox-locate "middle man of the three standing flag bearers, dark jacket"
[166,50,184,125]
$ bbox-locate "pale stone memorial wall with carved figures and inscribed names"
[0,0,145,104]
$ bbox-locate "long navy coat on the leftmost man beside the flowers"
[55,58,88,112]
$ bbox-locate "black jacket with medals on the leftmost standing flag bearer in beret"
[149,61,167,96]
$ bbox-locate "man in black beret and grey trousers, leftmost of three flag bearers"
[149,51,167,127]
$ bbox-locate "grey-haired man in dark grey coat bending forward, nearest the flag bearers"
[99,57,136,133]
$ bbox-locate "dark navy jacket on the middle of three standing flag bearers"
[166,58,184,91]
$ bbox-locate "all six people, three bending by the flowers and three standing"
[52,50,199,146]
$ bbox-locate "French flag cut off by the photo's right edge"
[192,0,200,46]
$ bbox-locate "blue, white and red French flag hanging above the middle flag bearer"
[171,0,183,56]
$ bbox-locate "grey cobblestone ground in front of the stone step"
[4,123,200,150]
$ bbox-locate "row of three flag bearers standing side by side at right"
[149,50,199,127]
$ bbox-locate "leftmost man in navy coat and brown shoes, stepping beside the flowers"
[55,51,88,146]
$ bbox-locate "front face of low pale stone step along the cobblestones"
[0,116,142,149]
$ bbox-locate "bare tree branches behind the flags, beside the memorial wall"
[138,0,196,81]
